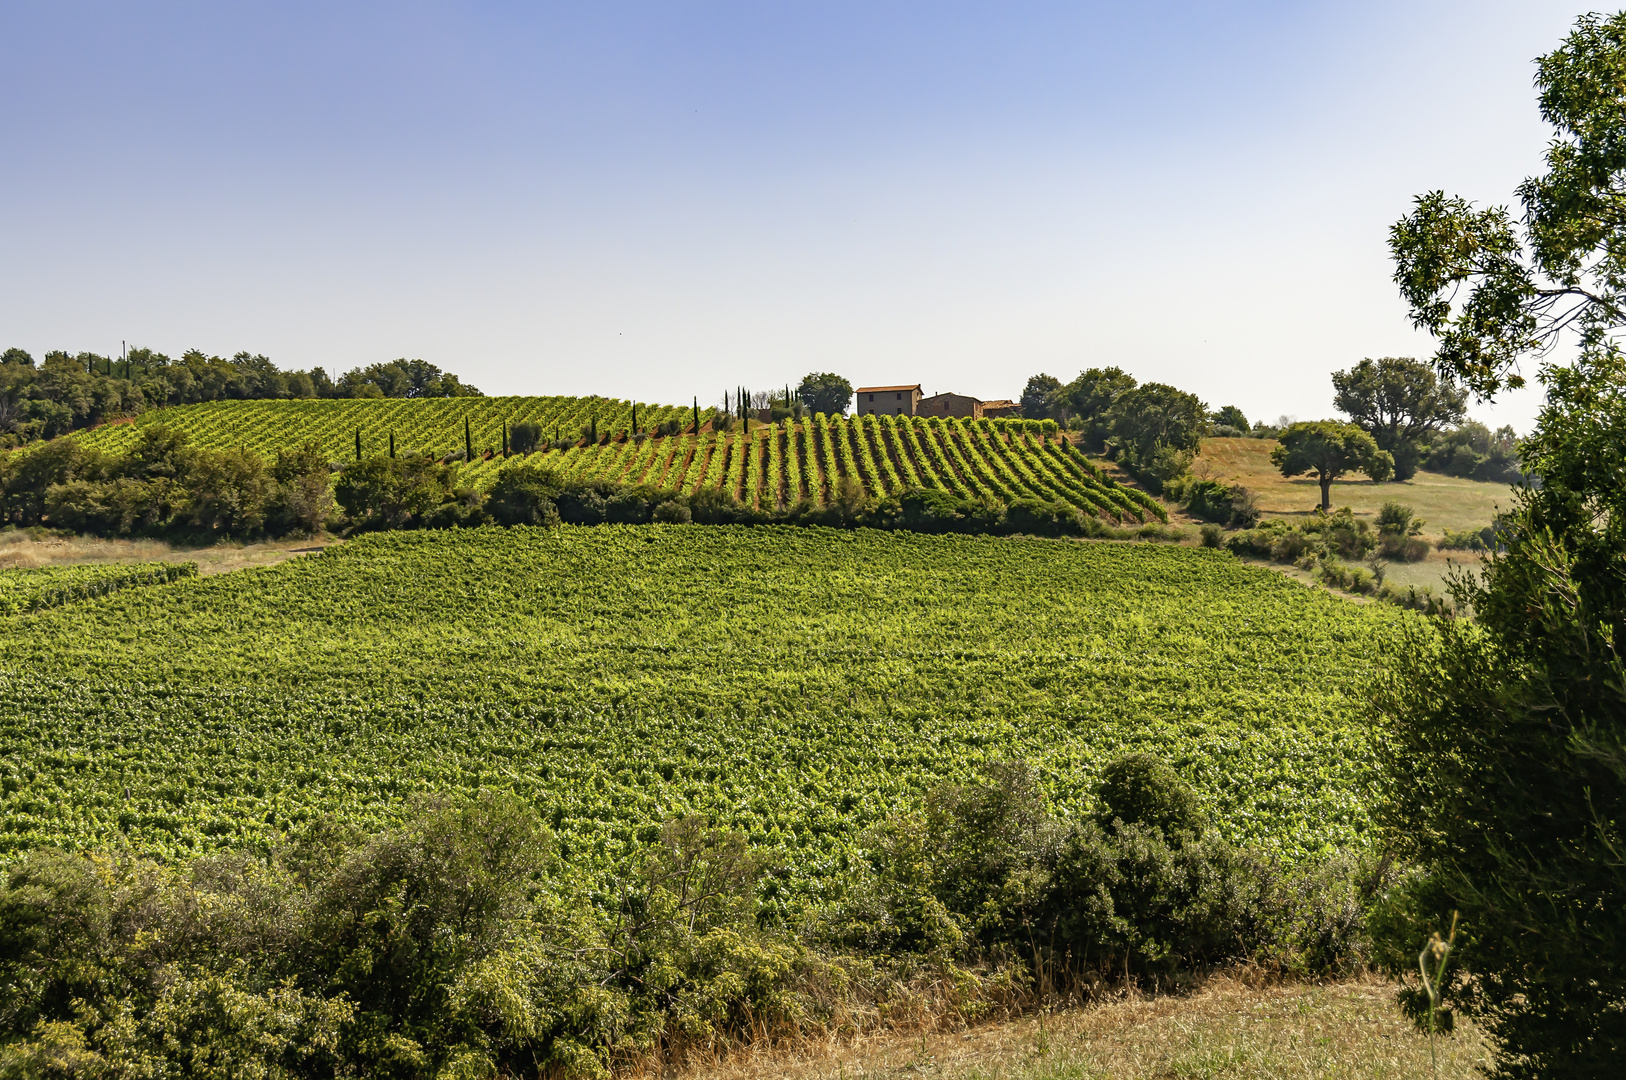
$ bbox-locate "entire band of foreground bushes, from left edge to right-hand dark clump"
[0,758,1377,1077]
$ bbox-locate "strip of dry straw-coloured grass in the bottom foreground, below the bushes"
[668,979,1488,1080]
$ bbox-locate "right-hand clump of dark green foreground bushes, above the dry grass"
[836,761,1382,981]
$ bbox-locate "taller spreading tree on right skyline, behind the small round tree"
[1332,356,1468,480]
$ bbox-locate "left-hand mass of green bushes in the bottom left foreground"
[0,792,802,1077]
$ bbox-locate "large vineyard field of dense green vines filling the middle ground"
[0,525,1410,884]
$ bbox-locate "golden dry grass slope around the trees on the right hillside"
[1192,439,1512,540]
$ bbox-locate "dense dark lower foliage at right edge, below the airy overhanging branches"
[1379,343,1626,1077]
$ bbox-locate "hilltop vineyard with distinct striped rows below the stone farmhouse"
[80,397,1167,522]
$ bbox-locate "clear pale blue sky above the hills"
[0,0,1585,429]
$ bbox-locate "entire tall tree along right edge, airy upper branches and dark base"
[1376,13,1626,1077]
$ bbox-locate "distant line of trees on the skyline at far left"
[0,348,481,446]
